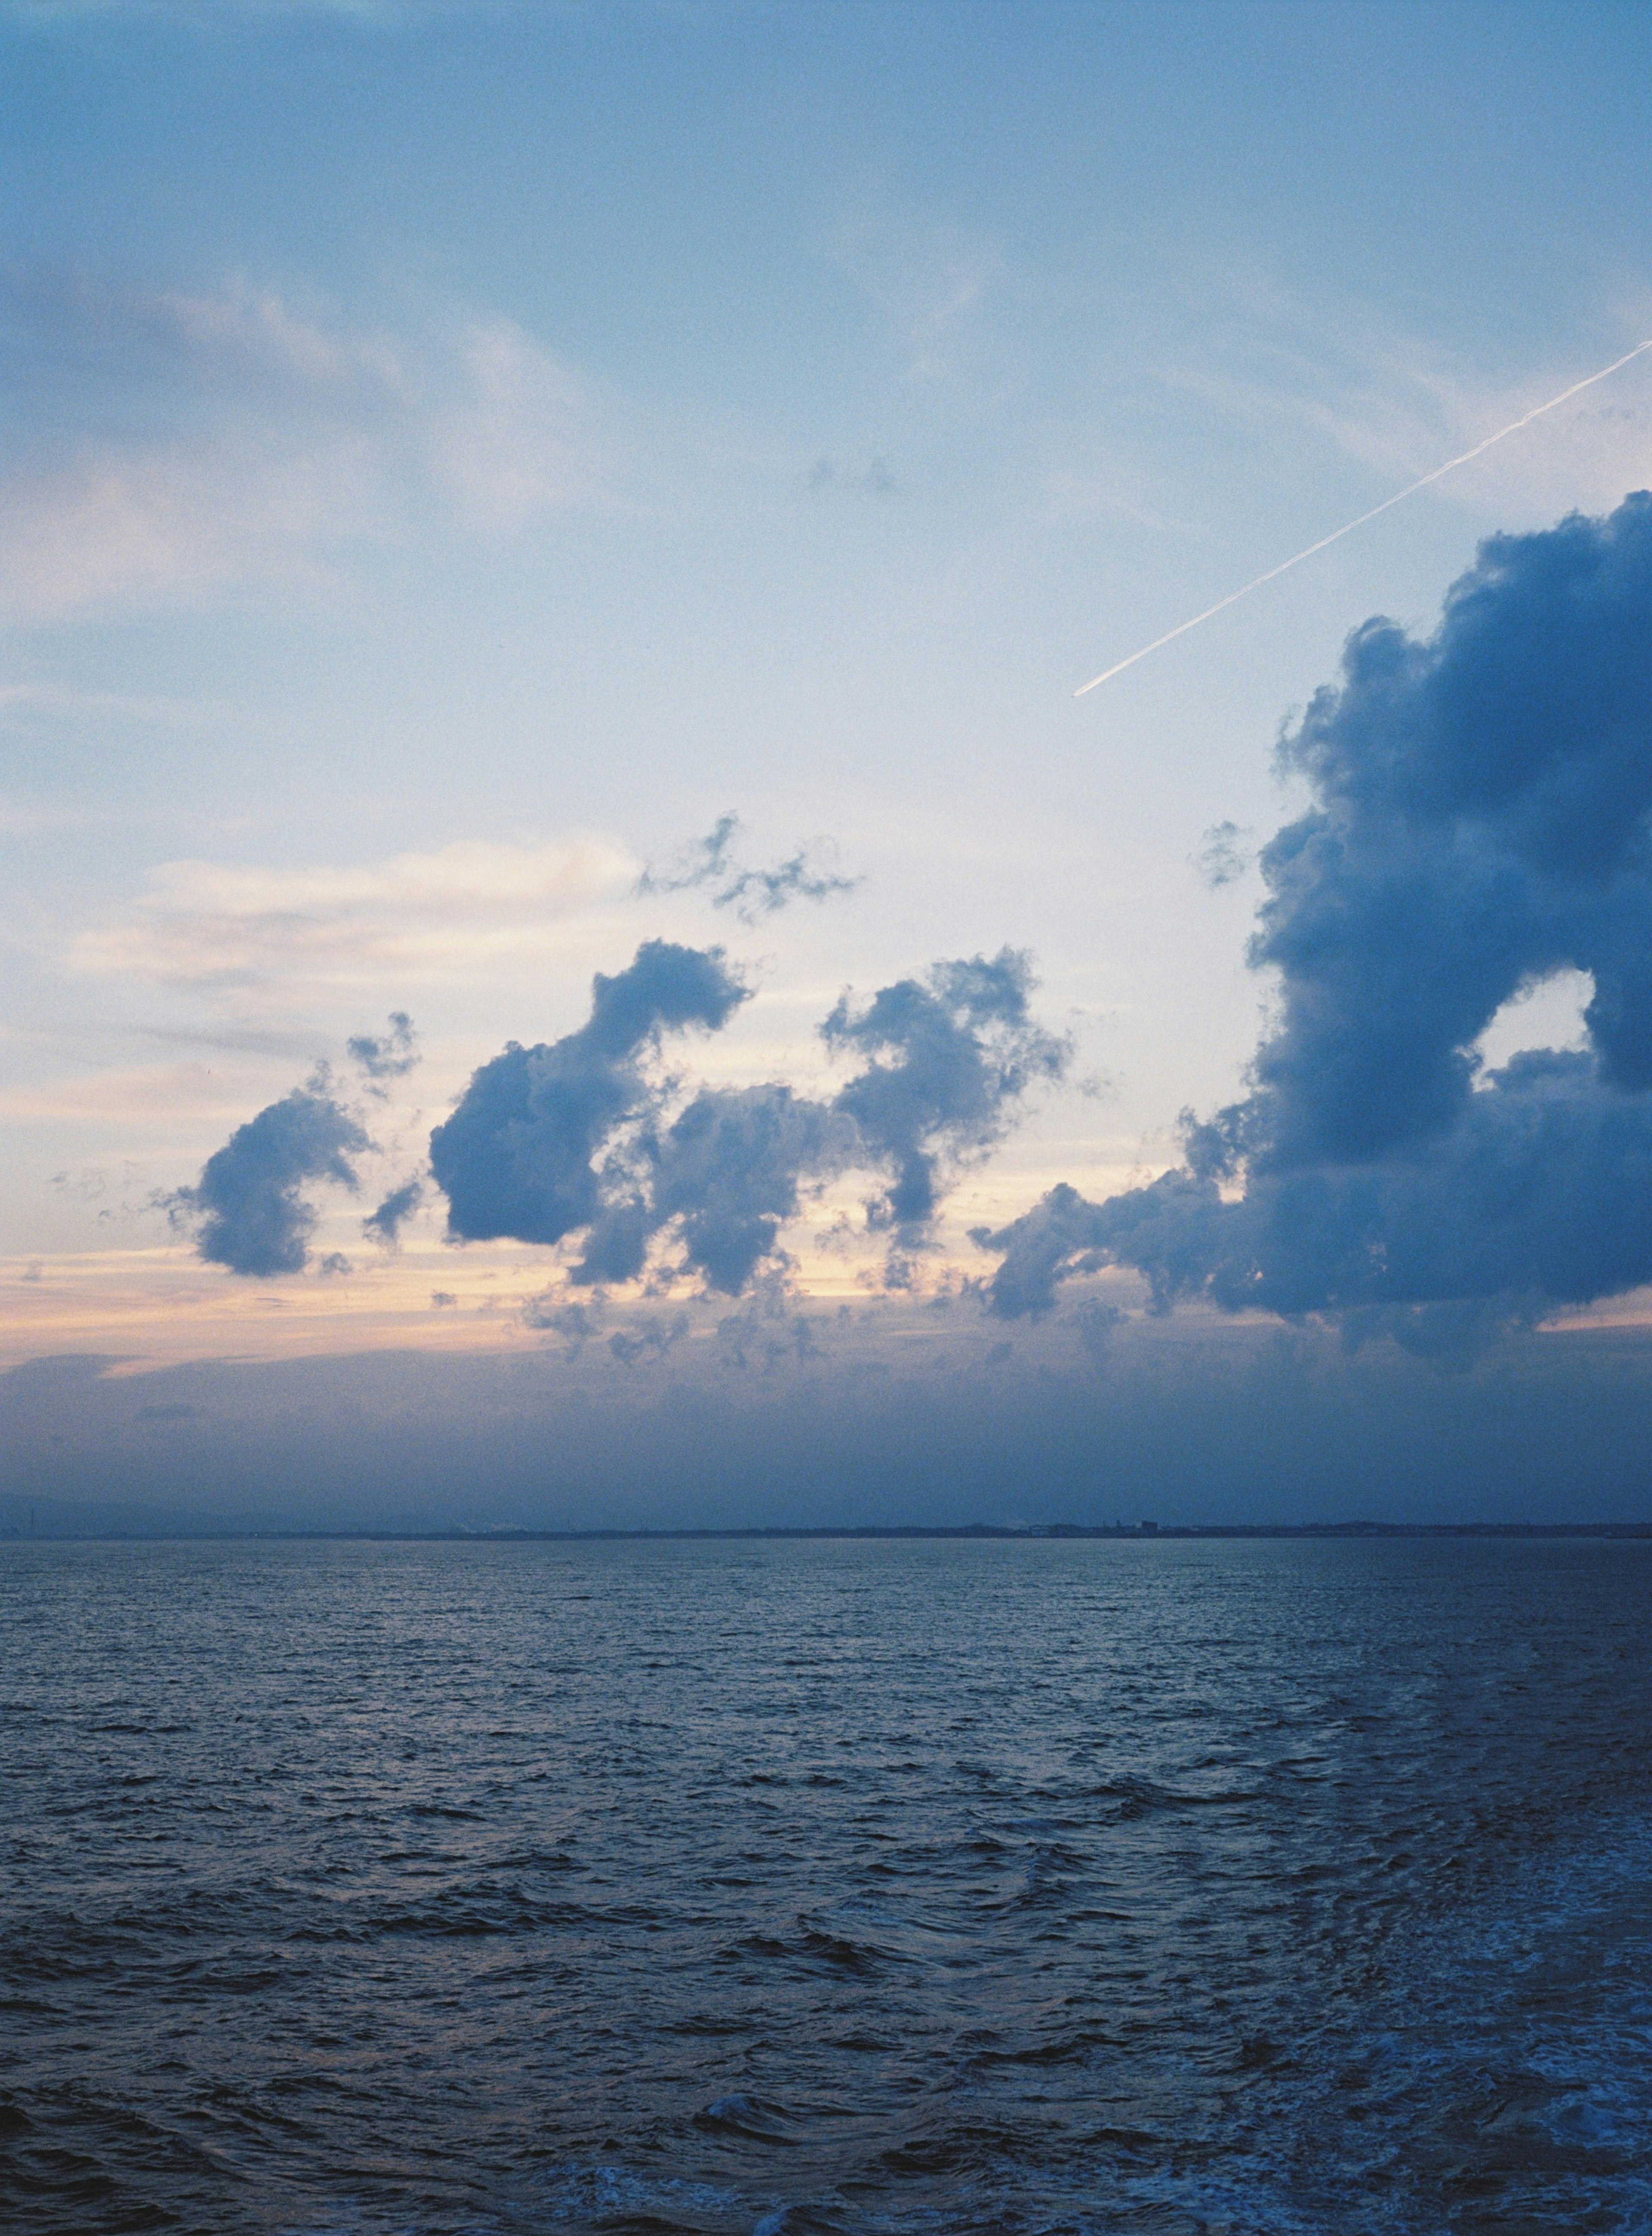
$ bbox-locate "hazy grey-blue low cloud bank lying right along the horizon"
[19,1288,1652,1534]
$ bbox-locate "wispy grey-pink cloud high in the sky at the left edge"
[0,271,617,621]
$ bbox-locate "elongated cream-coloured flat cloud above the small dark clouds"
[69,839,637,988]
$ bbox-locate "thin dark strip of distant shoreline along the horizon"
[0,1523,1652,1545]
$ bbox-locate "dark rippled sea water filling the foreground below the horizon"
[0,1541,1652,2236]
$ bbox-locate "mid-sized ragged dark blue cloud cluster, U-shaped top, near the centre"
[429,939,1069,1294]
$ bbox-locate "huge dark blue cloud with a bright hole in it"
[979,494,1652,1364]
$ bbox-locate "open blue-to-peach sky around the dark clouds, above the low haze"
[0,0,1652,1505]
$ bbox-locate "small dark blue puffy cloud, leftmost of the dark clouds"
[163,1071,371,1279]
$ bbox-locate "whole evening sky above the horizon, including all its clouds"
[0,0,1652,1527]
